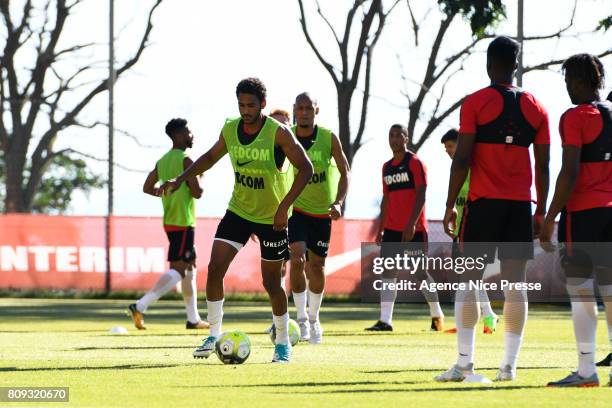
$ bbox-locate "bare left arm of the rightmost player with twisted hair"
[540,145,581,251]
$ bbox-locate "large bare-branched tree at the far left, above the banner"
[0,0,162,212]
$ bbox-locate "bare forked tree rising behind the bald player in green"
[298,0,399,163]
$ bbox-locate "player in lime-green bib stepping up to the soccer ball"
[162,78,312,363]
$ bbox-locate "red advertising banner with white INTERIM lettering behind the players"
[0,214,380,294]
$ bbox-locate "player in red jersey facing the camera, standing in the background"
[366,124,444,331]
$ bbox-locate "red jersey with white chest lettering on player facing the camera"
[382,152,427,232]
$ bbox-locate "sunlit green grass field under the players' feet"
[0,299,612,407]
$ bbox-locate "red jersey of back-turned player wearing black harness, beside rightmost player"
[459,84,550,201]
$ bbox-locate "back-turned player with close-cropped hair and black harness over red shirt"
[435,36,550,381]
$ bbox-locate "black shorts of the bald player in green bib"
[289,211,331,258]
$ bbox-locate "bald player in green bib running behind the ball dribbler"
[289,92,349,344]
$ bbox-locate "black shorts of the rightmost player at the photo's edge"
[557,207,612,267]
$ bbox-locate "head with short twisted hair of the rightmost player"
[561,54,605,104]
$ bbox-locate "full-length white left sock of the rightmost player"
[566,278,597,377]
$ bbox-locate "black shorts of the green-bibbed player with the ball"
[215,210,289,261]
